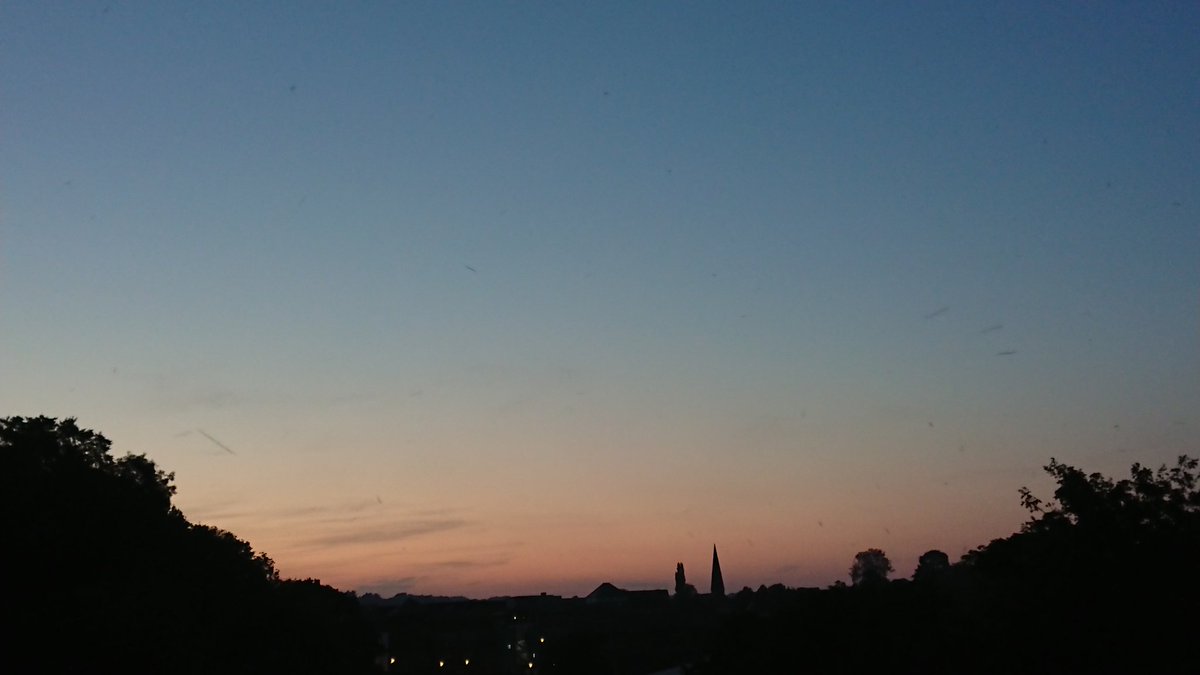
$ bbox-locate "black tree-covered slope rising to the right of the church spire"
[702,456,1200,675]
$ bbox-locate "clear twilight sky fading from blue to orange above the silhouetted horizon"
[0,0,1200,597]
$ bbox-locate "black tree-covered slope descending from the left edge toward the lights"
[0,417,374,674]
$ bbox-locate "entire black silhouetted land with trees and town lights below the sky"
[0,417,1200,675]
